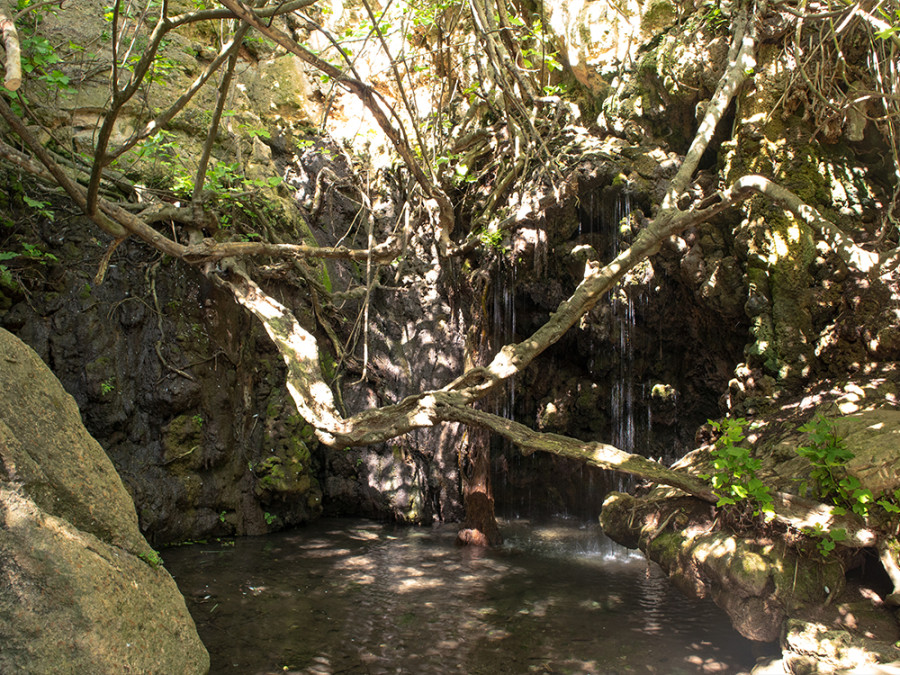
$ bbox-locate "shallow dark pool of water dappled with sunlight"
[163,520,772,675]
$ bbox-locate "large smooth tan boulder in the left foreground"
[0,329,209,675]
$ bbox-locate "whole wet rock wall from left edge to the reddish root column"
[0,136,472,544]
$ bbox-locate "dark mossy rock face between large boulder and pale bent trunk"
[0,230,321,543]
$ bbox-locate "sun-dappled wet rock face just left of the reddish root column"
[324,263,466,524]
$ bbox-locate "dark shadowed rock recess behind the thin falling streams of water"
[488,170,747,517]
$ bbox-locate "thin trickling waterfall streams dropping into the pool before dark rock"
[485,186,653,518]
